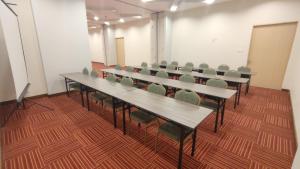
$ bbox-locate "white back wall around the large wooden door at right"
[171,0,300,68]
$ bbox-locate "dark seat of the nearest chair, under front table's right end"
[158,122,193,141]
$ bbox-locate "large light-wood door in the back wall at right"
[248,22,297,90]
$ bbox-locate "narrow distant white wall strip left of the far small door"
[89,28,105,63]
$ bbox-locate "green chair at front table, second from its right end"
[128,83,166,140]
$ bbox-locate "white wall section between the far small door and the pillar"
[115,19,151,66]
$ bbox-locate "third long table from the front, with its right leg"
[134,66,245,108]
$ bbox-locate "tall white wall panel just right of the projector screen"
[31,0,91,94]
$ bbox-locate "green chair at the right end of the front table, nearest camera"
[155,90,201,155]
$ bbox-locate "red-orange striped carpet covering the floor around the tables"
[2,65,296,169]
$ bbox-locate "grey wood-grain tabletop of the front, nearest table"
[61,73,213,129]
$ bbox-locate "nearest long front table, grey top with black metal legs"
[61,73,213,168]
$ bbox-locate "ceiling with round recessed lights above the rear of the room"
[86,0,230,27]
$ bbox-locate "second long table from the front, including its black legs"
[102,69,237,132]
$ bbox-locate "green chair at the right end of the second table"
[200,79,228,132]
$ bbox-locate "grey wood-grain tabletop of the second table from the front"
[102,69,236,99]
